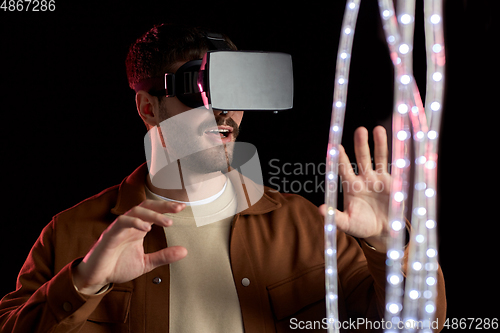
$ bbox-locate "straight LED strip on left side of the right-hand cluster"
[379,0,421,328]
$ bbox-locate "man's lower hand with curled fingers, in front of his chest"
[73,200,187,295]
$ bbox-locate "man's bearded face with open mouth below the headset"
[155,63,243,174]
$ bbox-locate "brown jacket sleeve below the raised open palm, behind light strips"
[337,227,446,332]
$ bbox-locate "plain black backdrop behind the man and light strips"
[0,0,499,328]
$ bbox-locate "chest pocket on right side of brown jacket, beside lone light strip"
[267,264,325,321]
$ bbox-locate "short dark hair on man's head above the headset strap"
[126,24,236,90]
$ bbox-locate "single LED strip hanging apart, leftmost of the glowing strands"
[325,0,361,333]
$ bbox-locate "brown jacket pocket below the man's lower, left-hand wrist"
[88,285,132,324]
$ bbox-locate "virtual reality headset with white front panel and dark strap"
[136,33,293,111]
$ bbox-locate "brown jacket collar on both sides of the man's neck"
[111,163,281,215]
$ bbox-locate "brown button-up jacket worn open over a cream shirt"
[0,165,446,333]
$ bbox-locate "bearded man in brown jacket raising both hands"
[0,25,445,333]
